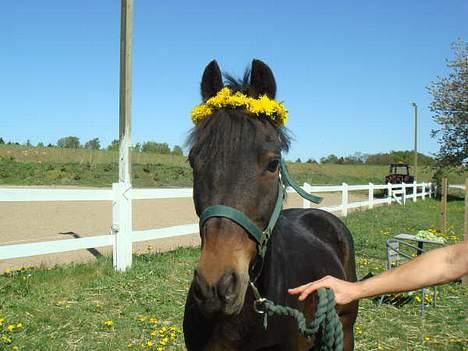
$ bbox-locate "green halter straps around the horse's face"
[200,159,322,258]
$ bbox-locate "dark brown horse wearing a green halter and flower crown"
[184,60,357,351]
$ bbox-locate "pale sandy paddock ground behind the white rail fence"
[0,188,367,274]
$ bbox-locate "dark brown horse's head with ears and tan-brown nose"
[188,60,289,315]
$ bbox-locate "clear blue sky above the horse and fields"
[0,0,468,159]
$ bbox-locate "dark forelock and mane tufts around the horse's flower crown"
[185,69,291,165]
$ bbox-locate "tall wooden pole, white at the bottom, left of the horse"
[113,0,133,271]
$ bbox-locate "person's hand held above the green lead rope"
[288,275,359,305]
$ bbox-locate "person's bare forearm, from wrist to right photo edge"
[354,242,468,299]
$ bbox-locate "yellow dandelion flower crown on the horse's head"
[192,88,288,126]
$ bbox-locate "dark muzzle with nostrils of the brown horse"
[192,270,244,315]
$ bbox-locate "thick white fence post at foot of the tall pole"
[112,182,132,272]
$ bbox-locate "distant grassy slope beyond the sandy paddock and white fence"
[0,145,464,187]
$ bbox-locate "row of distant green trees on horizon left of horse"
[0,136,183,155]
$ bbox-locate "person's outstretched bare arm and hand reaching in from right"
[288,240,468,304]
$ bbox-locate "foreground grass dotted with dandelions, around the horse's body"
[0,200,468,351]
